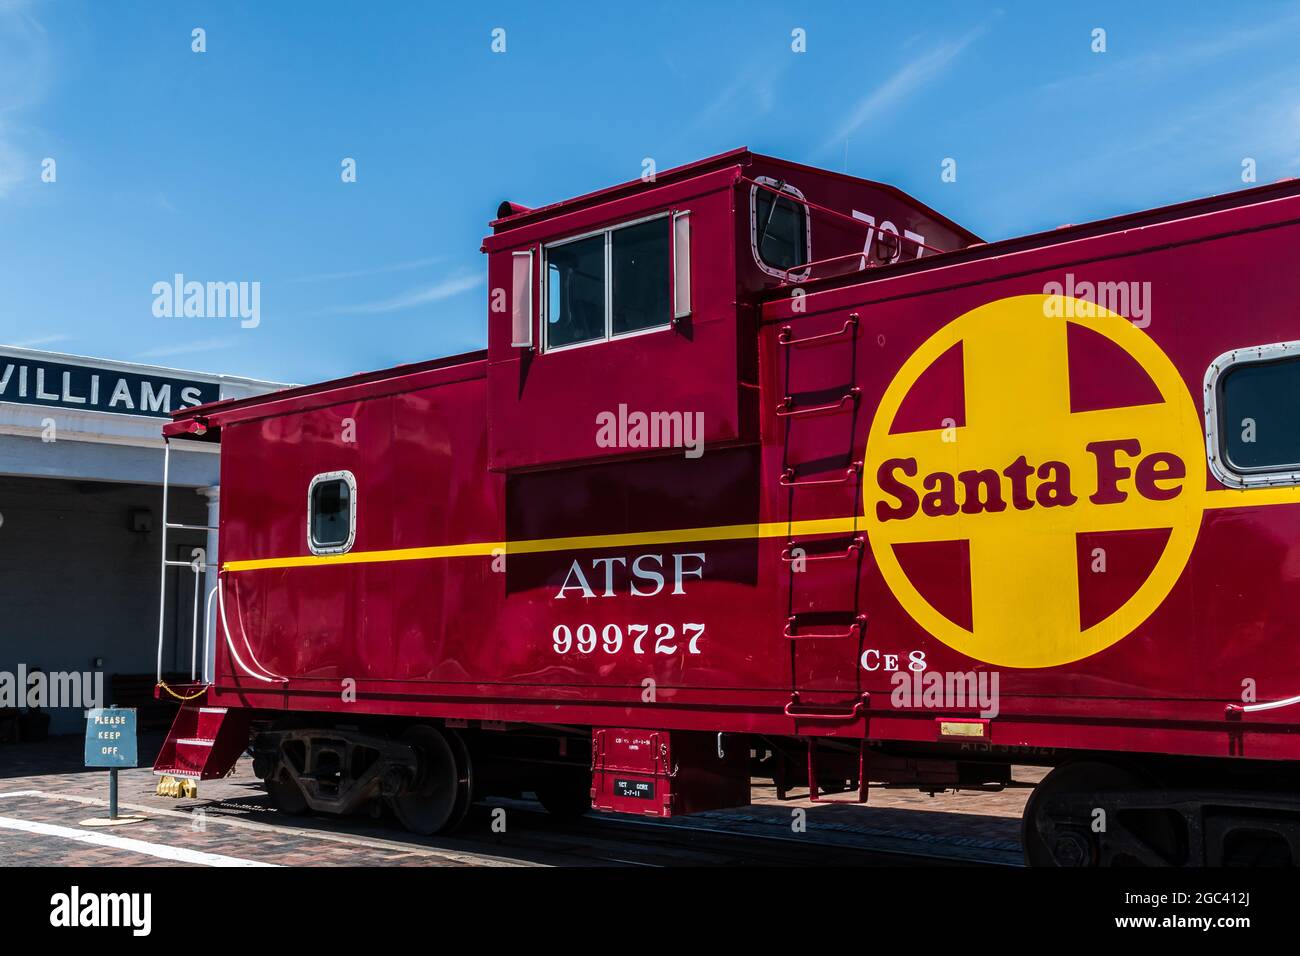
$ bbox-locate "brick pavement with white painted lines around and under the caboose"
[0,737,1044,866]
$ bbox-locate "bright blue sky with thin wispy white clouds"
[0,0,1300,381]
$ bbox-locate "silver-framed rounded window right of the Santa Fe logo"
[1205,342,1300,488]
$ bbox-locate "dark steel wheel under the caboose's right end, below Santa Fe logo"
[1021,761,1182,866]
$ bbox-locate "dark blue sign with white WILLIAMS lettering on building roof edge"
[0,355,221,418]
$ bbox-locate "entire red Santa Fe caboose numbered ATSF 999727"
[156,150,1300,865]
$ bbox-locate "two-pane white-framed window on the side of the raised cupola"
[543,213,689,351]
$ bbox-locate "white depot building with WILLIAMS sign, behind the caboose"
[0,346,285,734]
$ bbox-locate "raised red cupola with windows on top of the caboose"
[482,150,976,471]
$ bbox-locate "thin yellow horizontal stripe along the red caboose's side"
[222,488,1300,571]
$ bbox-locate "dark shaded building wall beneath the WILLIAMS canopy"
[0,476,206,734]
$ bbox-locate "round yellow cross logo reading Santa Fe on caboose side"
[863,295,1205,667]
